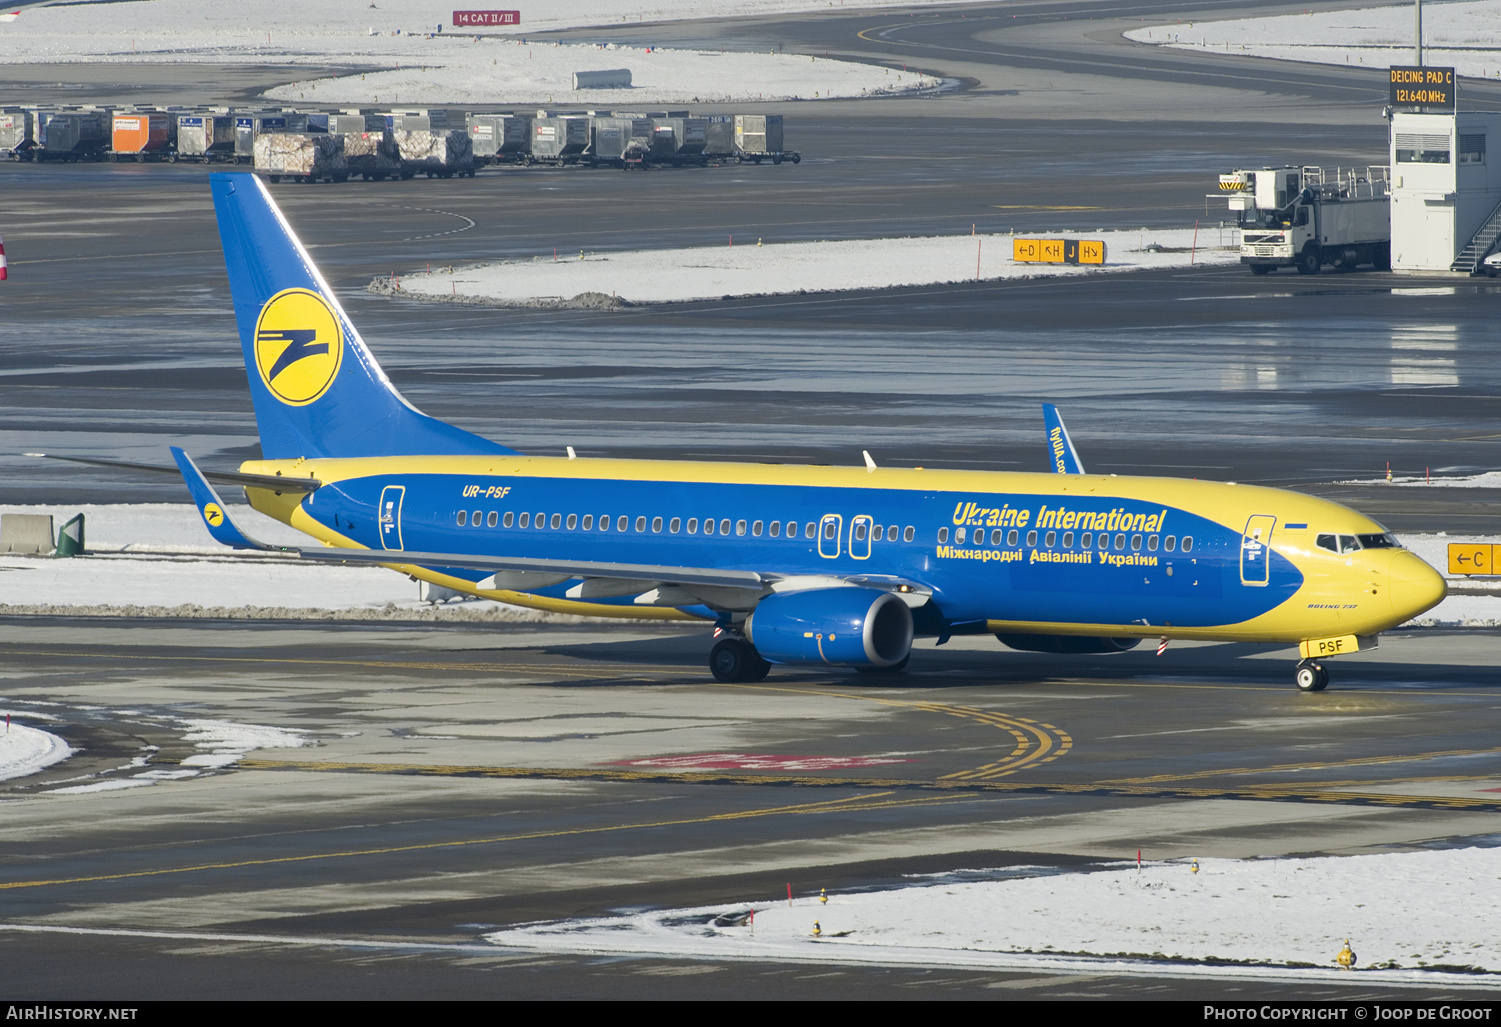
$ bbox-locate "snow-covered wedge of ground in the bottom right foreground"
[486,848,1501,988]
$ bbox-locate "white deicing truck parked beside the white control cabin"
[1219,167,1391,275]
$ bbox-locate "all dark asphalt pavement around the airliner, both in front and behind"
[0,3,1501,997]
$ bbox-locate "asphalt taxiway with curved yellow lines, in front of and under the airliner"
[0,619,1501,997]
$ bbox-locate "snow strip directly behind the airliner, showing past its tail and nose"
[0,503,1501,628]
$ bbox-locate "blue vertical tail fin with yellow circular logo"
[210,173,515,459]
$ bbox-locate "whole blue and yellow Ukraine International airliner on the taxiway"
[52,174,1444,691]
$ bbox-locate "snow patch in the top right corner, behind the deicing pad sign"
[1126,0,1501,78]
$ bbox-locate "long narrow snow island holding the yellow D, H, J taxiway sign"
[384,228,1240,305]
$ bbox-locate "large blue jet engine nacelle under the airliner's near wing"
[744,587,913,667]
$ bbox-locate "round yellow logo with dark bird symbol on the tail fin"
[255,288,344,407]
